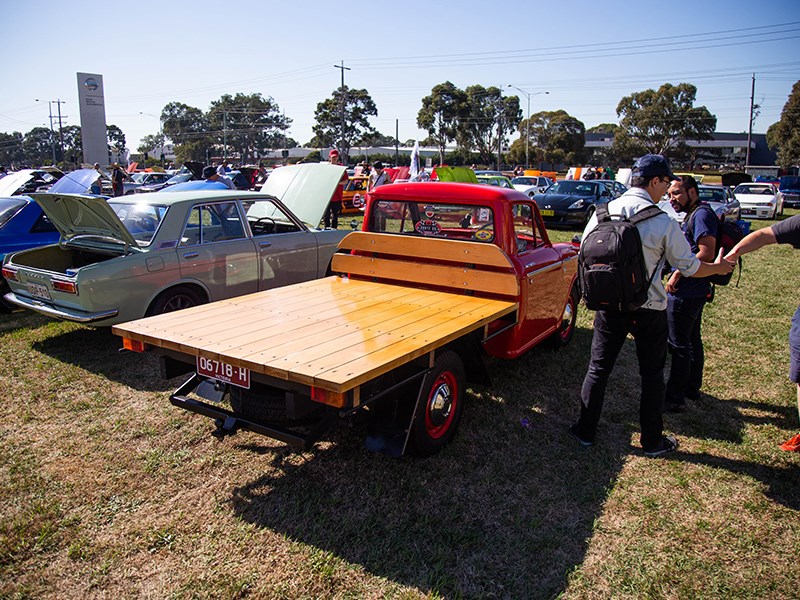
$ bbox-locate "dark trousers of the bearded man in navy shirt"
[666,296,706,404]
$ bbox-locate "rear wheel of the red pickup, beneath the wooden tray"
[407,351,466,457]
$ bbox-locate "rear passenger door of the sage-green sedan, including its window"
[178,200,258,301]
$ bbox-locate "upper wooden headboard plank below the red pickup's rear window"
[339,231,513,269]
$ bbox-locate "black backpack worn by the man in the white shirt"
[578,203,664,312]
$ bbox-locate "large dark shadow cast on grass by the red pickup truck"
[231,331,630,598]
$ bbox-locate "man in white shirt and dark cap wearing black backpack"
[570,154,734,457]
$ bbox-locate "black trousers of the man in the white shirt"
[578,308,667,450]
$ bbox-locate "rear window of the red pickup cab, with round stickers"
[369,200,494,243]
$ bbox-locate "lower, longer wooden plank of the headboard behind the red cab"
[331,254,519,297]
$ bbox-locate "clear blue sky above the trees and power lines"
[0,0,800,151]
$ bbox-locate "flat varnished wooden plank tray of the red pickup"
[112,276,518,393]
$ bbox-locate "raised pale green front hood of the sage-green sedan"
[261,163,345,227]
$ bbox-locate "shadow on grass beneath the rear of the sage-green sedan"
[33,327,175,392]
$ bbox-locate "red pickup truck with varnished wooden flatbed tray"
[113,182,579,456]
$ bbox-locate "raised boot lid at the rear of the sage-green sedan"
[33,194,139,248]
